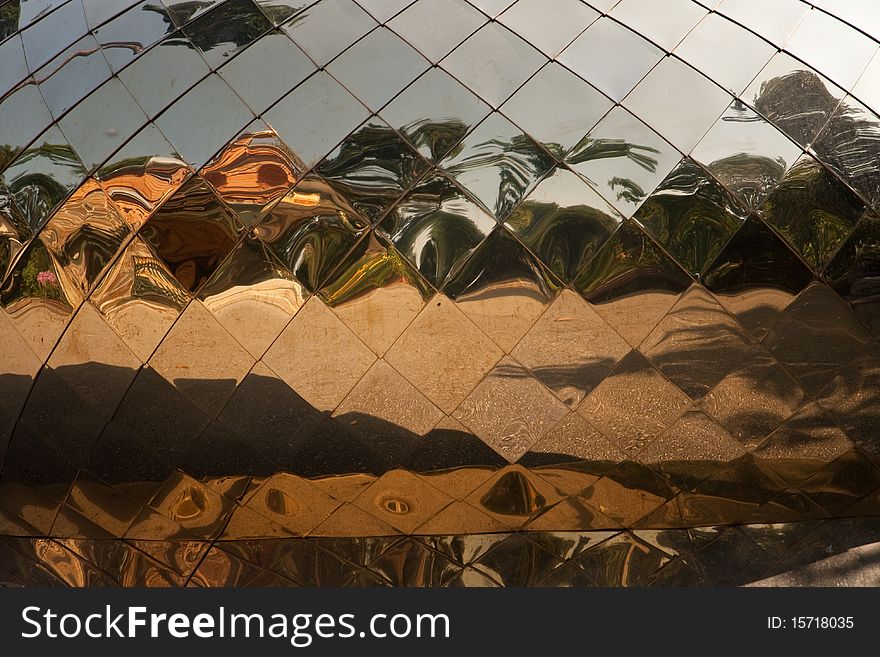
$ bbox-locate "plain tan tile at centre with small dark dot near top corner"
[385,294,503,413]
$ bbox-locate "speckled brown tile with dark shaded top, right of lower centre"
[577,351,690,458]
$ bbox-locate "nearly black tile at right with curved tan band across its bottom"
[703,216,813,339]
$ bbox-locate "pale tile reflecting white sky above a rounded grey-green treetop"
[691,100,801,208]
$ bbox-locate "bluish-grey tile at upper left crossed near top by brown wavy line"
[34,34,113,119]
